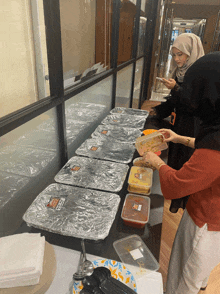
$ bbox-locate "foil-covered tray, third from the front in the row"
[76,138,136,163]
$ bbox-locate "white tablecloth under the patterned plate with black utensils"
[46,245,163,294]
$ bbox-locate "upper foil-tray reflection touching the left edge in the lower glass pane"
[0,145,56,177]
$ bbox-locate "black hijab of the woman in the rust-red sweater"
[180,52,220,151]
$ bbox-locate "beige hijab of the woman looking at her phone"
[171,33,204,83]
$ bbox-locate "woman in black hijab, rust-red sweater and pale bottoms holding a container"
[144,52,220,294]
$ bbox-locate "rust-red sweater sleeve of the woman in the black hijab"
[159,149,220,199]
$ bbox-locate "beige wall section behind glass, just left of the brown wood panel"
[60,0,96,73]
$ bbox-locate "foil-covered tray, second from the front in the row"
[54,156,129,192]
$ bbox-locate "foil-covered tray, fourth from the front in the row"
[91,125,142,143]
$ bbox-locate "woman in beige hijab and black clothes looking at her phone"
[150,33,204,213]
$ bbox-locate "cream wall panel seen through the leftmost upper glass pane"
[0,0,38,117]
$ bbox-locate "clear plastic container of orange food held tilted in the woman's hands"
[135,132,168,156]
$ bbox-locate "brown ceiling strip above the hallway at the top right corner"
[170,0,220,19]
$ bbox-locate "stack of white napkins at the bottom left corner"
[0,233,45,288]
